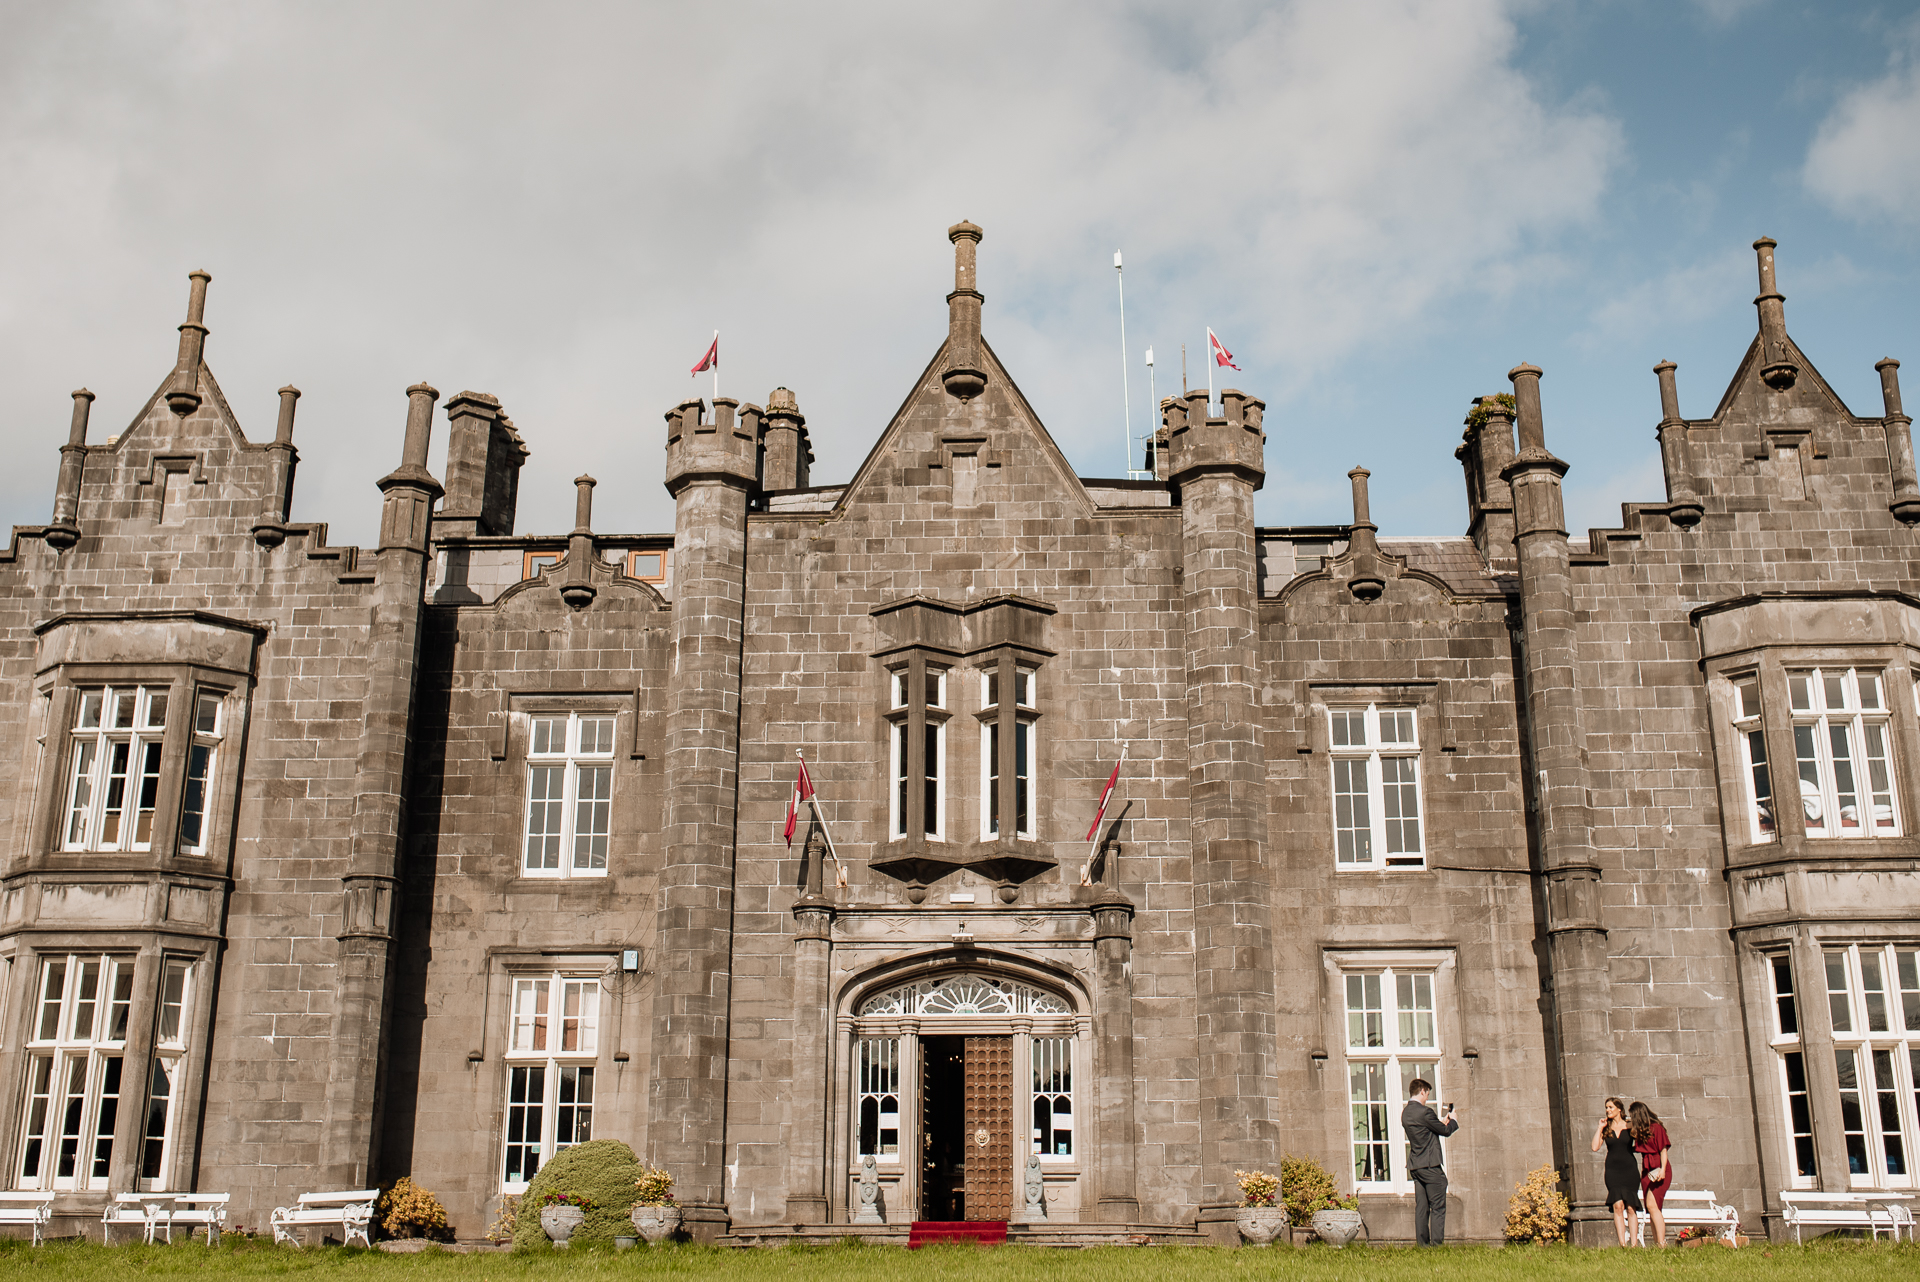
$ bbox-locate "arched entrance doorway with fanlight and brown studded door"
[847,969,1085,1221]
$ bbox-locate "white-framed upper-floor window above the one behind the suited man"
[1327,704,1427,869]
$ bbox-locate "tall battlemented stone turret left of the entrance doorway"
[647,397,758,1240]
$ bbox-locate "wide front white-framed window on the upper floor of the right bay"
[1786,668,1901,837]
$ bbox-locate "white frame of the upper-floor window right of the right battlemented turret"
[1325,702,1427,871]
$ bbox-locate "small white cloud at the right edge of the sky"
[1801,27,1920,223]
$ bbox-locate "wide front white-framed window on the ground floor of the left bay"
[15,954,132,1190]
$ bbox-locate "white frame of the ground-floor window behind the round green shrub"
[499,969,607,1194]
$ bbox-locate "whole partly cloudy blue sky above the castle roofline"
[0,0,1920,539]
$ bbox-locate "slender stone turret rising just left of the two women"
[1501,365,1615,1223]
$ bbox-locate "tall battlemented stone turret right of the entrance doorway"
[1165,379,1281,1242]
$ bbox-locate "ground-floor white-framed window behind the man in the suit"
[1340,965,1444,1192]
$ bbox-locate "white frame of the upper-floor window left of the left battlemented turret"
[518,708,618,877]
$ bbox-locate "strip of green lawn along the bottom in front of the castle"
[0,1238,1920,1282]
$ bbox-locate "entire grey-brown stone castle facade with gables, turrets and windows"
[0,223,1920,1240]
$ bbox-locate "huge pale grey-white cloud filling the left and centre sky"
[0,0,1622,537]
